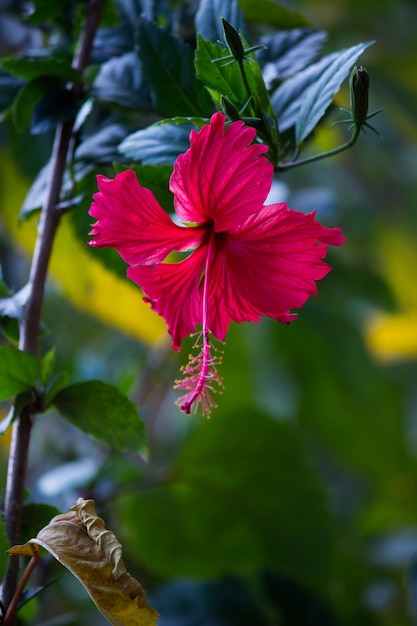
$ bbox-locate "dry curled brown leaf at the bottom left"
[9,498,158,626]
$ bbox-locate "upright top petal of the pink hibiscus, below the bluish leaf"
[170,113,273,232]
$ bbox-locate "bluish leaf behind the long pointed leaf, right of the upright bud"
[256,28,327,87]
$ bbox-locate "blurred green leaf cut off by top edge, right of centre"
[239,0,308,29]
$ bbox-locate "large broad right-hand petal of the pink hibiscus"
[203,204,344,341]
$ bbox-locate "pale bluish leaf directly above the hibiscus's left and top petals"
[119,124,193,165]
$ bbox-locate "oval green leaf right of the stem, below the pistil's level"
[53,380,146,452]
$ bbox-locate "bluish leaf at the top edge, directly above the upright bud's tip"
[195,0,245,42]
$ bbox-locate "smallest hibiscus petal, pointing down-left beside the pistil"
[127,245,207,350]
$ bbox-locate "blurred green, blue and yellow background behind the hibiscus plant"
[0,0,417,626]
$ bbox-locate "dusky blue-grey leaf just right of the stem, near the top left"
[92,52,152,109]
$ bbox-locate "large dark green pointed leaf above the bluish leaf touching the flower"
[138,19,213,117]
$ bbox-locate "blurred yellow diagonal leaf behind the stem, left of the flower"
[0,153,168,344]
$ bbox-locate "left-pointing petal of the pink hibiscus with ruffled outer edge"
[89,170,203,265]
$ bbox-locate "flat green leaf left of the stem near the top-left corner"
[1,56,80,82]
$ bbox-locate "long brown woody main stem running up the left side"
[2,0,104,611]
